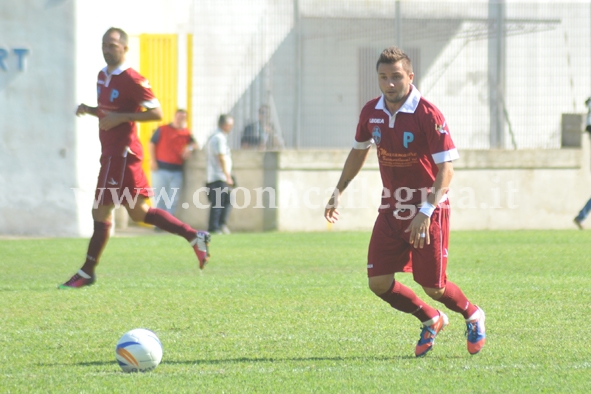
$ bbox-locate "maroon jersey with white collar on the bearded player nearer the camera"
[354,86,459,211]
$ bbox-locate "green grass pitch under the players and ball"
[0,231,591,393]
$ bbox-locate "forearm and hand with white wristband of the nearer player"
[405,161,454,248]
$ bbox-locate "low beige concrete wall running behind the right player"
[175,136,591,231]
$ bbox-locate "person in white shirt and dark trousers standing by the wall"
[206,115,234,234]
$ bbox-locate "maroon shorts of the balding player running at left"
[94,154,153,205]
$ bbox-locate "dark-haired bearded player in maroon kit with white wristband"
[324,47,486,357]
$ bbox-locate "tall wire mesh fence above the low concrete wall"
[192,0,591,149]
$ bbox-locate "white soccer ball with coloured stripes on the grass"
[115,328,162,372]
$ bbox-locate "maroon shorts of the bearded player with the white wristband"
[367,200,449,288]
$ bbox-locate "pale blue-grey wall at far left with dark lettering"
[0,0,78,235]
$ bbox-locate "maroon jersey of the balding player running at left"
[97,65,160,159]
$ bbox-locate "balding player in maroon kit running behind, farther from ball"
[59,28,210,289]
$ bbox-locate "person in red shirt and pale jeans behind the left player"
[150,109,197,215]
